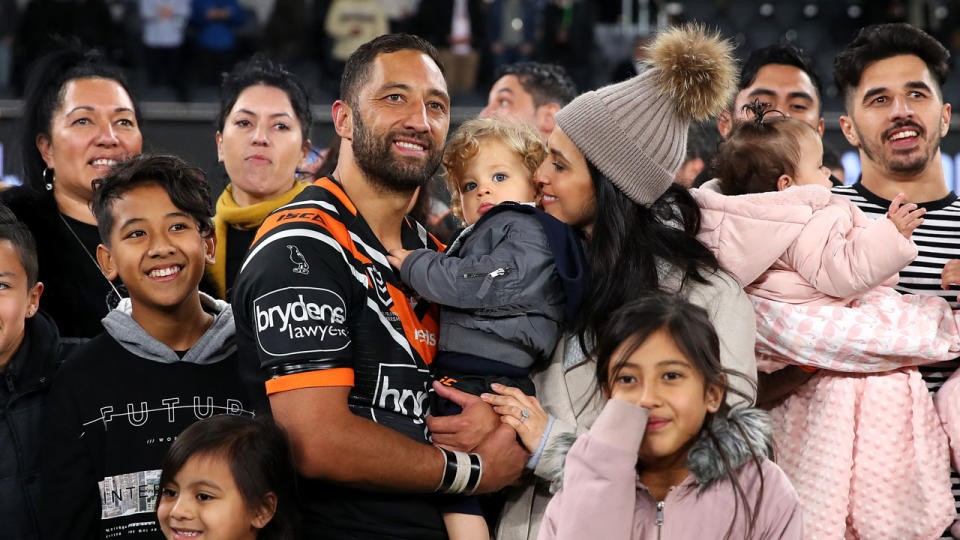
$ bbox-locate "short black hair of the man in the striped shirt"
[833,23,950,107]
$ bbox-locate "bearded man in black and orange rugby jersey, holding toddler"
[234,35,528,539]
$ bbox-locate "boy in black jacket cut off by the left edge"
[0,205,61,539]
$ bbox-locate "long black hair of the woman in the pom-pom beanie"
[574,161,719,355]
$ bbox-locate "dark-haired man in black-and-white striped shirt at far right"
[834,24,960,532]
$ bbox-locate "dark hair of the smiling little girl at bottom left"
[157,414,297,540]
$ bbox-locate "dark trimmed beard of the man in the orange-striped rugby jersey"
[352,109,443,193]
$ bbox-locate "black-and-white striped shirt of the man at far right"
[833,181,960,538]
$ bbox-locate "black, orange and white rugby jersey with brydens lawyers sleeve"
[233,178,445,538]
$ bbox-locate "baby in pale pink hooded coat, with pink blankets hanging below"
[692,110,960,538]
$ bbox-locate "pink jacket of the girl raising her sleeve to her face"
[538,399,803,540]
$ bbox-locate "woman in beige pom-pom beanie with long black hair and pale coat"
[487,26,756,540]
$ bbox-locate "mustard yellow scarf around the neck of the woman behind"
[207,182,310,299]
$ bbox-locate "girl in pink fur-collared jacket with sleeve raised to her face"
[539,295,802,539]
